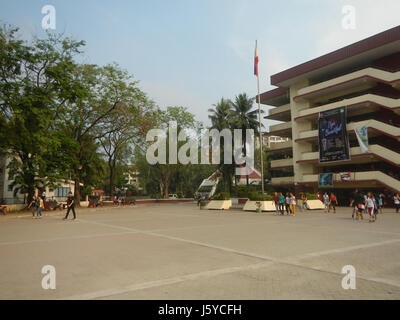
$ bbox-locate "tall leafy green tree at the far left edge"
[0,27,83,199]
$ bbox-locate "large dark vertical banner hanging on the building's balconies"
[318,107,350,162]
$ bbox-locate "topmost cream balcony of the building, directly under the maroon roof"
[294,68,400,100]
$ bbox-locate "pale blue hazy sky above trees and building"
[0,0,400,130]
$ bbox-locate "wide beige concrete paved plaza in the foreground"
[0,203,400,299]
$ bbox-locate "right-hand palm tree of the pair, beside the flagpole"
[231,93,264,186]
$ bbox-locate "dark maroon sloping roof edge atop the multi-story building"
[270,26,400,87]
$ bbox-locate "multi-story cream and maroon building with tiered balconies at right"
[260,26,400,202]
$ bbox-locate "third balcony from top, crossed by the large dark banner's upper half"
[295,119,400,142]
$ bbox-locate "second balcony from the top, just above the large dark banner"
[295,93,400,121]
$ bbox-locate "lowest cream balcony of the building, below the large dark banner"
[299,171,400,192]
